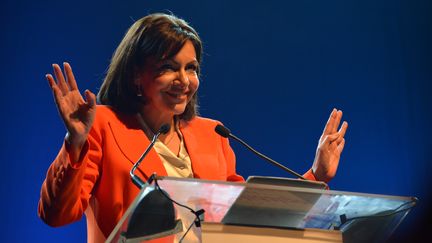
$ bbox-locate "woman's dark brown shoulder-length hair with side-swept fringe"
[97,13,202,120]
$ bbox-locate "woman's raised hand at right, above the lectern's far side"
[312,109,348,182]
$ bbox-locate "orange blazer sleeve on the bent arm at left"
[38,126,102,226]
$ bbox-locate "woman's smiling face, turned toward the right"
[135,40,199,116]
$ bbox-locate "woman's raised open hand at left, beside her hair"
[46,62,96,160]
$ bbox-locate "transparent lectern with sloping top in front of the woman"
[107,177,416,243]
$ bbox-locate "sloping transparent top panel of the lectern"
[155,177,414,229]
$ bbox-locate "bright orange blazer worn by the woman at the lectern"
[38,106,313,242]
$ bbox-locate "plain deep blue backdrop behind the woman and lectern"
[0,0,432,242]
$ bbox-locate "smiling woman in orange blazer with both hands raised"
[38,14,347,242]
